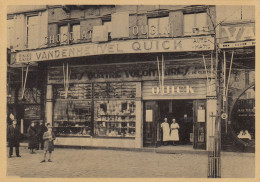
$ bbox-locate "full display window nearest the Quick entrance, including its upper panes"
[94,82,136,137]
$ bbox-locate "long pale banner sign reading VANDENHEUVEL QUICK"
[12,36,214,63]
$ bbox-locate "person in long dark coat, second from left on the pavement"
[27,120,38,154]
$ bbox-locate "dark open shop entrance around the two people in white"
[143,100,206,149]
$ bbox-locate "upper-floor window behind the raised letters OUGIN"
[148,17,170,37]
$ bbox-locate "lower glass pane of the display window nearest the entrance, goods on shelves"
[94,100,136,137]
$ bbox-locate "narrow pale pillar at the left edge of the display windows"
[46,85,53,125]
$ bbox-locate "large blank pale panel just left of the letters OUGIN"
[111,12,129,39]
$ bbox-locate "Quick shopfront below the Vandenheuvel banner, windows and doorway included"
[42,54,215,149]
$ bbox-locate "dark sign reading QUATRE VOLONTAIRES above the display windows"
[48,63,210,84]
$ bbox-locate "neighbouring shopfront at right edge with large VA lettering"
[220,22,256,152]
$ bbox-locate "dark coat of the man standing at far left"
[7,125,21,147]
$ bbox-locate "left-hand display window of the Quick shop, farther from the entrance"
[53,84,92,136]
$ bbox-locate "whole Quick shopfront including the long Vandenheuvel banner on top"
[13,36,216,149]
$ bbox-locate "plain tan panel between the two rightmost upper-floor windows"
[169,11,184,37]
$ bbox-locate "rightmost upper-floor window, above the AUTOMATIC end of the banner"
[184,13,208,35]
